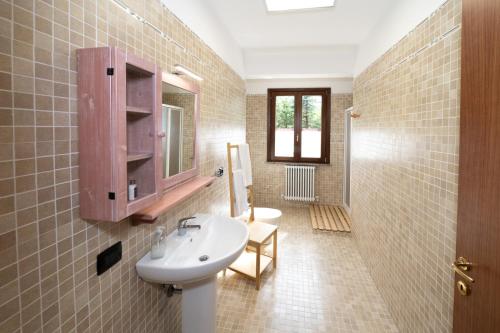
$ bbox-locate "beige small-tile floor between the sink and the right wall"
[217,208,397,333]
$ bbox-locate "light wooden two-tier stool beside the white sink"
[228,222,278,290]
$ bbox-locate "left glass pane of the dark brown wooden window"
[274,96,295,157]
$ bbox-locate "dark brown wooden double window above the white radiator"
[267,88,330,164]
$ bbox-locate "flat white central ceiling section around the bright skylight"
[206,0,396,49]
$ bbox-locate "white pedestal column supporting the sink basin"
[182,275,217,333]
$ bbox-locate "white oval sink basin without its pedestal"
[136,214,248,284]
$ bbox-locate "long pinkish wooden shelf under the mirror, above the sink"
[132,176,215,224]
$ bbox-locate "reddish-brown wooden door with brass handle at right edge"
[453,0,500,333]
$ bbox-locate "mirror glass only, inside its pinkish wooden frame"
[162,82,196,178]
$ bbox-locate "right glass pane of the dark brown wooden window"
[301,96,323,158]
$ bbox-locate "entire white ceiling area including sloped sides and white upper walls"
[166,0,445,82]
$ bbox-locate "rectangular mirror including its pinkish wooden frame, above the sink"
[159,73,199,188]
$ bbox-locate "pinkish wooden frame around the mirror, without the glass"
[157,72,200,192]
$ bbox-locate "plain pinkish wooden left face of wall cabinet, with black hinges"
[77,48,117,221]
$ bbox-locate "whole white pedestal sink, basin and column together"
[136,214,248,333]
